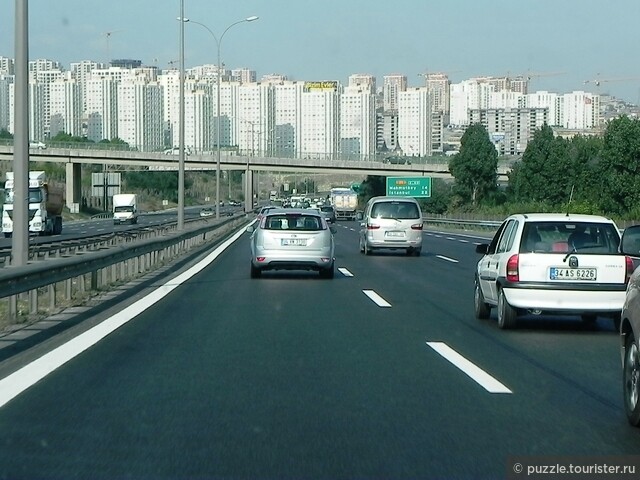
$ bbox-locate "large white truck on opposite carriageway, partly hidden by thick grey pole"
[2,171,64,238]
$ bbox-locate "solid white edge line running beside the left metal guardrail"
[0,222,252,407]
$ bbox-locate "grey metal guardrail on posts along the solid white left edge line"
[0,216,248,326]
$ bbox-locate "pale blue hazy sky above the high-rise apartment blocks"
[0,0,640,103]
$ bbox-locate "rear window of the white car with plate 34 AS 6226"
[520,222,620,254]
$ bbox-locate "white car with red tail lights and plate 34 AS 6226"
[474,213,634,328]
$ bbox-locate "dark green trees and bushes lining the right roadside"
[360,117,640,221]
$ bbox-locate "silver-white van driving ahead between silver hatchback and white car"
[357,197,422,256]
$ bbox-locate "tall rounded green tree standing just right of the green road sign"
[449,123,498,206]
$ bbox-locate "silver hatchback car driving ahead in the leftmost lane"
[247,208,336,278]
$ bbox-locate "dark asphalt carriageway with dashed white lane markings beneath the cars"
[0,222,640,479]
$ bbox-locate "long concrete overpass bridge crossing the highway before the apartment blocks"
[0,144,511,206]
